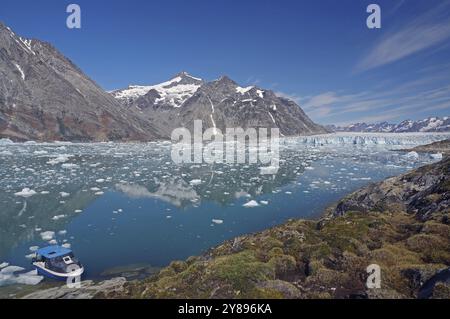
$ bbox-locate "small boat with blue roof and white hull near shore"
[33,246,84,281]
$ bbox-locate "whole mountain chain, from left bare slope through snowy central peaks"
[0,23,328,142]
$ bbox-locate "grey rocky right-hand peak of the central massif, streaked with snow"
[180,77,326,136]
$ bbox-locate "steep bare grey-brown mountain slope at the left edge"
[0,24,162,141]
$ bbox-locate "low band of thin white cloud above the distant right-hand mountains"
[300,75,450,125]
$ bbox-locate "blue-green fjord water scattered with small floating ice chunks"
[0,139,442,278]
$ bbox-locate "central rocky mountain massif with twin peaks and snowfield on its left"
[112,72,327,137]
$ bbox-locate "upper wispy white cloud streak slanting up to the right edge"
[355,1,450,72]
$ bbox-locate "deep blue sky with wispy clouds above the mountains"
[0,0,450,125]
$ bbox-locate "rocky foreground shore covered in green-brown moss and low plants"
[7,140,450,299]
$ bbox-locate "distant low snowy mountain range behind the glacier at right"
[328,117,450,133]
